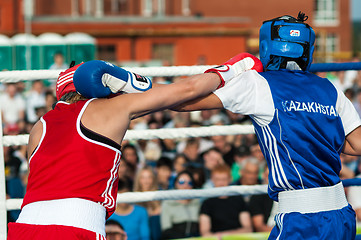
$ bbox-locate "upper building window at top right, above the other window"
[315,0,338,26]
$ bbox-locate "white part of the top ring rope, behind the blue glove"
[0,65,214,83]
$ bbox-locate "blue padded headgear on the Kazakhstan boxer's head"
[259,12,315,70]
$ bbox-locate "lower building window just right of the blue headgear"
[315,33,339,62]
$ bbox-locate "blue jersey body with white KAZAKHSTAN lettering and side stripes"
[253,70,345,200]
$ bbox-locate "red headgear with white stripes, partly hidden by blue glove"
[56,63,83,101]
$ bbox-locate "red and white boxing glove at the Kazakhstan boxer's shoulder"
[204,53,263,88]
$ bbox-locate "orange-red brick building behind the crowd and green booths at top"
[0,0,352,65]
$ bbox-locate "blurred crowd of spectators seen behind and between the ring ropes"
[0,59,361,240]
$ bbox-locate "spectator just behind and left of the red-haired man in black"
[203,148,224,188]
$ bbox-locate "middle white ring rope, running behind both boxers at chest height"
[3,124,254,146]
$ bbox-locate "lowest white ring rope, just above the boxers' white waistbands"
[6,185,267,210]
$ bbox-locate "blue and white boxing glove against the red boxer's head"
[73,60,152,98]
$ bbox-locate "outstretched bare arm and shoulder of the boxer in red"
[81,73,220,142]
